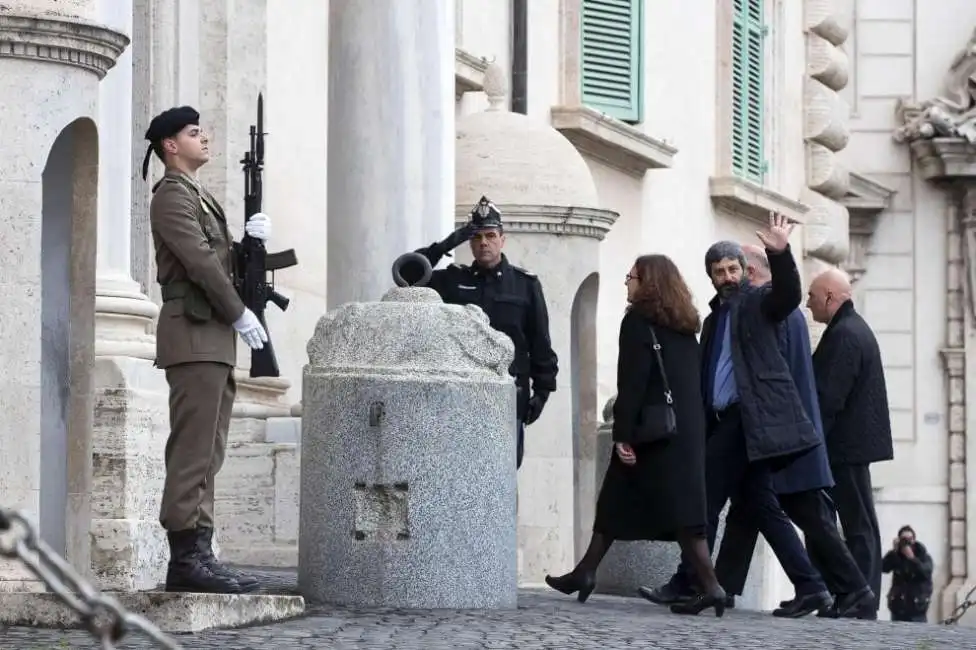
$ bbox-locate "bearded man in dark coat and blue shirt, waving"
[639,215,868,617]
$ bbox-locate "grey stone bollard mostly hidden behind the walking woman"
[596,397,725,596]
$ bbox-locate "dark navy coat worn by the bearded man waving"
[702,246,823,462]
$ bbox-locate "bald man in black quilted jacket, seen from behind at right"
[807,268,894,619]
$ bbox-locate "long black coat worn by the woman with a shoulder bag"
[593,310,706,541]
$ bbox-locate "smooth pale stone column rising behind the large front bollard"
[326,0,455,309]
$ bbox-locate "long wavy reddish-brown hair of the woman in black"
[631,255,701,334]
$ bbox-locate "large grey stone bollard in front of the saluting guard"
[298,287,518,609]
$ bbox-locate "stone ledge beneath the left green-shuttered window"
[549,106,678,178]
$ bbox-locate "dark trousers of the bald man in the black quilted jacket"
[810,464,884,612]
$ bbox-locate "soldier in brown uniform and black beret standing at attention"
[142,106,271,593]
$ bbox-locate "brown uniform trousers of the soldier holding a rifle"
[159,361,237,531]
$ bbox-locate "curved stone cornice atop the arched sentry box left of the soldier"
[0,13,129,79]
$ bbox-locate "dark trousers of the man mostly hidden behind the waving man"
[715,490,867,595]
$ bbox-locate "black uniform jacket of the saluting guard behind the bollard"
[417,249,558,394]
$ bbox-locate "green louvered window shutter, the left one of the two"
[580,0,644,123]
